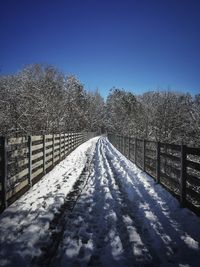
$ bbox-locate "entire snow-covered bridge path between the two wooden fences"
[0,137,200,267]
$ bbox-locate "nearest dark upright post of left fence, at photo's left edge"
[0,136,8,209]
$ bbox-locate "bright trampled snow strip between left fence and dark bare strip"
[0,138,98,267]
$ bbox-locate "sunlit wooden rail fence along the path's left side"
[0,132,96,214]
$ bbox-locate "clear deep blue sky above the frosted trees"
[0,0,200,95]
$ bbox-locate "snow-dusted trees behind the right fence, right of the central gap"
[106,89,200,146]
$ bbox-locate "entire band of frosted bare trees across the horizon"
[0,64,200,146]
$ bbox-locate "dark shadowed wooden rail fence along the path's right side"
[108,134,200,215]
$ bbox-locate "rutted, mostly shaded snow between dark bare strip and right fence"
[51,138,200,267]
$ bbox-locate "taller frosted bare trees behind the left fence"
[0,64,105,136]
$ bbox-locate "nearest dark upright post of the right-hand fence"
[180,144,187,207]
